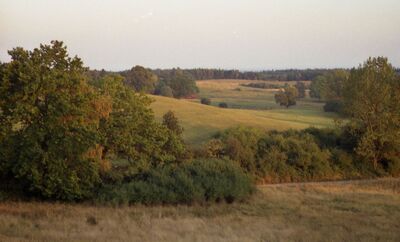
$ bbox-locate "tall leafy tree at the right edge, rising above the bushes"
[344,57,400,168]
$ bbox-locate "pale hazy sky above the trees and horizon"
[0,0,400,70]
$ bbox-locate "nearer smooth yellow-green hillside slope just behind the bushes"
[151,96,335,145]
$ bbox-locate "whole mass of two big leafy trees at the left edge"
[0,41,186,200]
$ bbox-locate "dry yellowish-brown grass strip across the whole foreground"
[0,179,400,241]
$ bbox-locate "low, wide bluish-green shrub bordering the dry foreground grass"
[97,160,254,204]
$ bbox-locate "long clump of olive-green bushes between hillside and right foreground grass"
[198,127,388,183]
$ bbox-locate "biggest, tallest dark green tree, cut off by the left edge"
[0,41,111,200]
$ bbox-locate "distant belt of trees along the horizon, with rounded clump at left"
[88,66,400,101]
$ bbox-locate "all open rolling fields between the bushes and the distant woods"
[151,80,337,145]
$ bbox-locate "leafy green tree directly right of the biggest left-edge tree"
[92,75,184,174]
